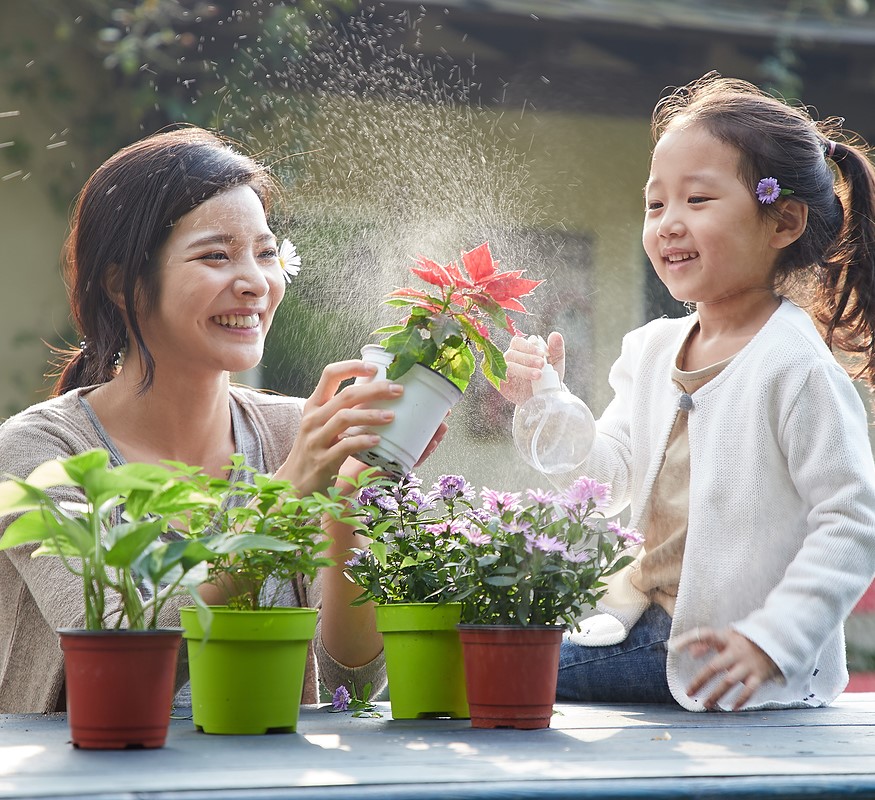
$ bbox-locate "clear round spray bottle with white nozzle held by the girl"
[513,336,596,474]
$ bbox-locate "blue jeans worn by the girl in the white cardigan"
[556,605,676,703]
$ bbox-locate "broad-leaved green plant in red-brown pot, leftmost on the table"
[0,449,215,748]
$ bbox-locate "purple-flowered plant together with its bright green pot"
[346,473,474,719]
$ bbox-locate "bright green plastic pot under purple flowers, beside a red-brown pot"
[376,603,469,719]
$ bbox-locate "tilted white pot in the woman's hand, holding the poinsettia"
[356,344,462,477]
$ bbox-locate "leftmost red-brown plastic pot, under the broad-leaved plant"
[58,628,182,750]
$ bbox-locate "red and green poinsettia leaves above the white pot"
[375,242,542,391]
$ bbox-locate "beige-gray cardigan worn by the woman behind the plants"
[0,387,385,713]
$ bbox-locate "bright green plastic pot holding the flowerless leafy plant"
[181,606,316,734]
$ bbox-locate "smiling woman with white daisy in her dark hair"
[0,128,442,712]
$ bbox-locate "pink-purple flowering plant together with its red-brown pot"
[448,477,638,728]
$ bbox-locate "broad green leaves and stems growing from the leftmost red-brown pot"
[0,449,218,630]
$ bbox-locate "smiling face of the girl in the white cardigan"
[642,125,779,303]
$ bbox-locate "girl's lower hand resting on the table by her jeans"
[671,628,781,711]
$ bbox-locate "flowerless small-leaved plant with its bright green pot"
[181,457,373,734]
